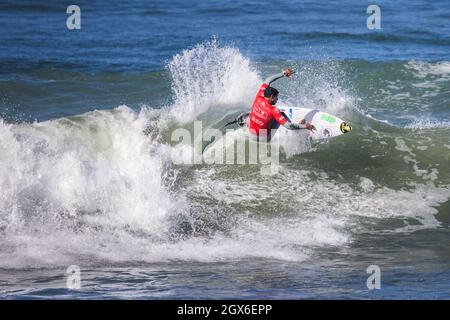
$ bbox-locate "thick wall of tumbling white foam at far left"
[0,106,183,265]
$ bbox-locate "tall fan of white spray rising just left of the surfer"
[167,39,261,123]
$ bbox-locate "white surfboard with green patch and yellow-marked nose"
[277,106,352,140]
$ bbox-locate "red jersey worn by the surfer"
[250,83,287,136]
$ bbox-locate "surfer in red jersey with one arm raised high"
[248,68,316,140]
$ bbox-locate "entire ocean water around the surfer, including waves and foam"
[0,0,450,299]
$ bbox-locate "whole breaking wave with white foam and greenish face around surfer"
[0,40,450,269]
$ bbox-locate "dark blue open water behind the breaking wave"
[0,1,450,72]
